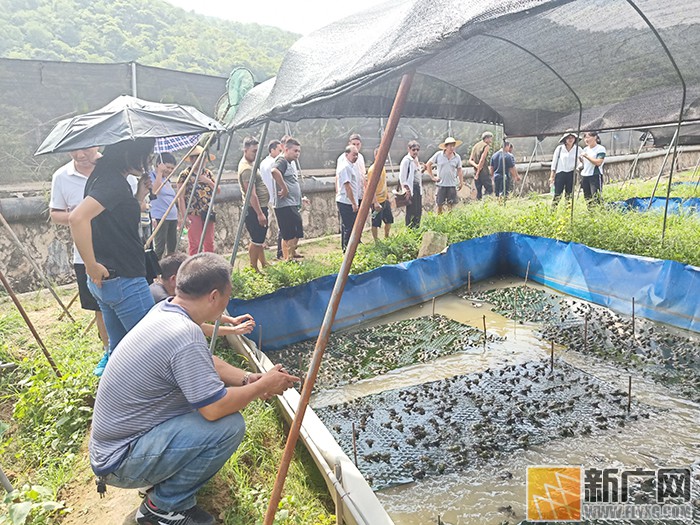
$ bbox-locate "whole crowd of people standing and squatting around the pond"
[49,131,605,524]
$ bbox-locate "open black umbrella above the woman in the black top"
[35,96,226,155]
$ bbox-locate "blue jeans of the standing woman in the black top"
[88,277,155,354]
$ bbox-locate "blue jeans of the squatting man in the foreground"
[105,411,245,512]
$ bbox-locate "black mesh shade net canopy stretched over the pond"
[235,0,700,135]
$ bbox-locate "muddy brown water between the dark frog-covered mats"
[312,279,700,525]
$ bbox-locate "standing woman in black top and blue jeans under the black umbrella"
[68,138,155,376]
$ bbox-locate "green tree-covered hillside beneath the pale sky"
[0,0,299,80]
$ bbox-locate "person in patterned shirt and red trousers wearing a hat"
[177,146,221,255]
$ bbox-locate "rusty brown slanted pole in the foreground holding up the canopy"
[263,70,415,525]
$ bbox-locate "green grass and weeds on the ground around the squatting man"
[0,290,335,525]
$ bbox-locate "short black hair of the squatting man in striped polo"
[176,252,231,298]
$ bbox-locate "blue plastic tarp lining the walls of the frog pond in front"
[228,232,700,350]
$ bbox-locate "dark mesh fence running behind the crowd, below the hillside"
[0,58,640,189]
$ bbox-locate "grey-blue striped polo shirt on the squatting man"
[89,299,226,476]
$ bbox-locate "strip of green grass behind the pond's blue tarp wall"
[232,172,700,299]
